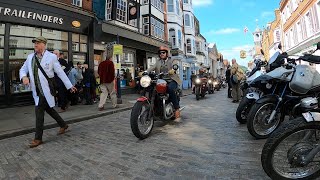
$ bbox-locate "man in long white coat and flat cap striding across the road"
[20,37,77,148]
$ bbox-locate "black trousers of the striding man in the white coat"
[35,95,67,140]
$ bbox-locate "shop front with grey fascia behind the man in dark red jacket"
[94,22,168,93]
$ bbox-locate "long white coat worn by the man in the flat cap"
[20,51,72,107]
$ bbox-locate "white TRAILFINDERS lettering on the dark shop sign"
[0,7,63,25]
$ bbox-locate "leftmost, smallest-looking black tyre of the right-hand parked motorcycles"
[236,97,254,124]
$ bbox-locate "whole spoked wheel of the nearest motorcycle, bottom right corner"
[261,117,320,179]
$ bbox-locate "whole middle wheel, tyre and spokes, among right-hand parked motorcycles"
[247,102,281,139]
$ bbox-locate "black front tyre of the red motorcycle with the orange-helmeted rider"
[130,101,154,140]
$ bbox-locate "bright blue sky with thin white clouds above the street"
[193,0,280,66]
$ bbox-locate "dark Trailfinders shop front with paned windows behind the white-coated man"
[0,0,93,107]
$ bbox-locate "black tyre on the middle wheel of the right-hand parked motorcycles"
[247,102,282,139]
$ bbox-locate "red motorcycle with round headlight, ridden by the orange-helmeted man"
[130,65,183,139]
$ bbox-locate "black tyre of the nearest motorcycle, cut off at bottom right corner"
[261,117,320,179]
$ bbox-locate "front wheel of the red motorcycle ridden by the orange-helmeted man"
[130,101,154,140]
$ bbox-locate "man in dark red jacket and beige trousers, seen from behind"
[98,52,117,111]
